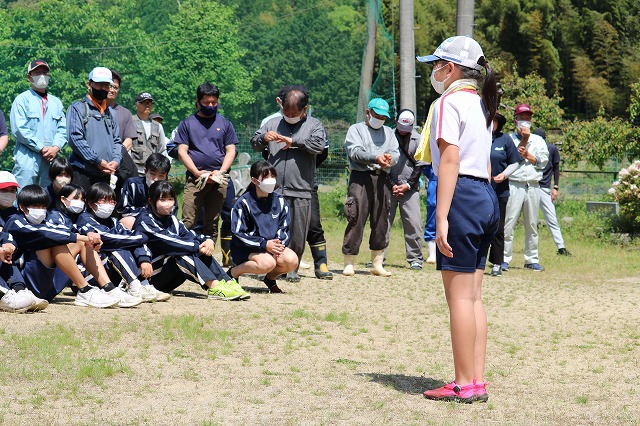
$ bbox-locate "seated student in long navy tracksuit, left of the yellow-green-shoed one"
[77,184,171,302]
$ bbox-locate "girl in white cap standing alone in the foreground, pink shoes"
[417,36,500,403]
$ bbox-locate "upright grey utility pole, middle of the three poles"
[400,0,417,114]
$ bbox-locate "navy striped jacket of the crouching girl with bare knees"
[231,185,290,253]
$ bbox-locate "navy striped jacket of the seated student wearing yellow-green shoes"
[133,207,208,258]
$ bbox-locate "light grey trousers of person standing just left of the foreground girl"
[387,189,423,263]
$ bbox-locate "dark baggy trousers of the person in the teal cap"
[342,170,391,255]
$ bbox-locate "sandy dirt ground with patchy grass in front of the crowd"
[0,255,640,425]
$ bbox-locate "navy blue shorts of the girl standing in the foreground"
[436,176,500,272]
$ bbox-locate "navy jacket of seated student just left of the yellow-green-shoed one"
[76,212,151,264]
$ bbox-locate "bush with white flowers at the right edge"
[609,160,640,231]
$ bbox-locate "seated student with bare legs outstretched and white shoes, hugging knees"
[5,185,142,308]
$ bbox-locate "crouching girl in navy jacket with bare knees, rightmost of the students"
[228,161,298,293]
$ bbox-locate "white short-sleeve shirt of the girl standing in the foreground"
[430,90,492,179]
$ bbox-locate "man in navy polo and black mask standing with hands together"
[175,82,238,241]
